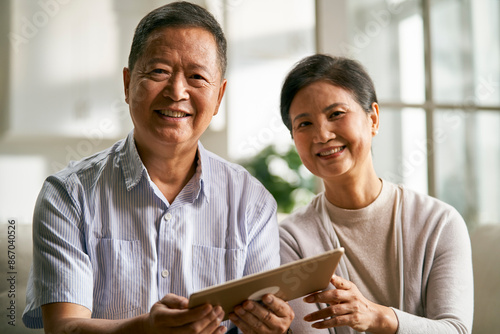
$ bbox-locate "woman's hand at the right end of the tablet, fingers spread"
[304,275,398,334]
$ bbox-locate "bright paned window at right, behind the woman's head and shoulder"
[317,0,500,228]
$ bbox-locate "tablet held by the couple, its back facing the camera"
[189,248,344,320]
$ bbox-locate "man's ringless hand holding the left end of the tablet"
[145,294,226,334]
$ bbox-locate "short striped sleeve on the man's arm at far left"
[23,176,93,328]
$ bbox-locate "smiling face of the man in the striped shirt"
[123,27,226,154]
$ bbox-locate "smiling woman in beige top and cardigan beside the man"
[280,55,473,334]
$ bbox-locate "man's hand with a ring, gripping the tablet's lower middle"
[229,294,295,334]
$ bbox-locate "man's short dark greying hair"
[128,1,227,77]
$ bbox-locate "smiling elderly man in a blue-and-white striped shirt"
[23,2,293,333]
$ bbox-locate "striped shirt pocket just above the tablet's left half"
[192,245,246,292]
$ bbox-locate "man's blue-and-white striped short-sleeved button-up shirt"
[23,132,280,328]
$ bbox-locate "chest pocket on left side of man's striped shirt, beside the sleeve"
[92,239,145,319]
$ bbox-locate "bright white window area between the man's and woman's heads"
[224,0,315,160]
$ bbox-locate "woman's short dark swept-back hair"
[280,54,377,132]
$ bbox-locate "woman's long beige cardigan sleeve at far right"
[393,210,474,334]
